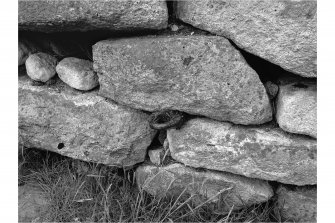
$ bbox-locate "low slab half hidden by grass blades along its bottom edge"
[136,163,273,211]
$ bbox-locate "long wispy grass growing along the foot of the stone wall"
[19,149,281,223]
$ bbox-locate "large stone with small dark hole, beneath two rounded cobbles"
[19,76,155,166]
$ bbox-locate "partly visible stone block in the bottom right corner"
[276,186,317,222]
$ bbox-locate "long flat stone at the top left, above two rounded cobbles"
[19,0,168,32]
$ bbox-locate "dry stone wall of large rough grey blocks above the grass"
[18,0,317,222]
